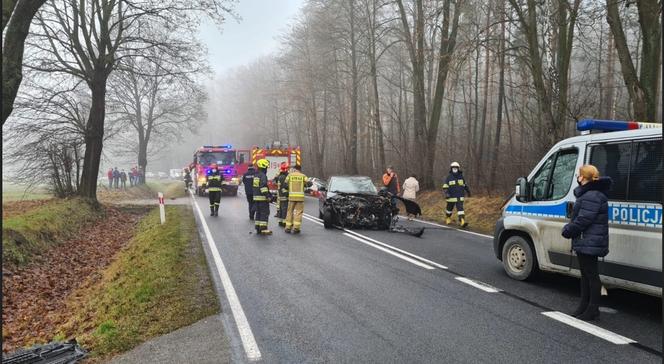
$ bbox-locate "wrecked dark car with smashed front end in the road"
[318,176,423,236]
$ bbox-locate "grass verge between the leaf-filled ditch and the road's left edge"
[59,206,219,358]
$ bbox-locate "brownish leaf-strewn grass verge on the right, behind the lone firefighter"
[417,191,504,235]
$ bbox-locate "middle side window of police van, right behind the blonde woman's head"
[590,142,632,201]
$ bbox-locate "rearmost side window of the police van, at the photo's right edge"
[627,140,662,203]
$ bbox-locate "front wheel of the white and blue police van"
[503,235,538,281]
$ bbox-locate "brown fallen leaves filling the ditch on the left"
[2,207,145,352]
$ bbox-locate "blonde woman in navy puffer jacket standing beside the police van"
[562,164,612,321]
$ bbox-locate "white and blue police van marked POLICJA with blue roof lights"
[493,120,663,297]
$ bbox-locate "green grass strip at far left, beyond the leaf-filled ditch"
[2,198,103,267]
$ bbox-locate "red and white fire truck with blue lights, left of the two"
[189,145,252,196]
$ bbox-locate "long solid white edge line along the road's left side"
[191,192,261,361]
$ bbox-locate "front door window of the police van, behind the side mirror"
[532,149,579,201]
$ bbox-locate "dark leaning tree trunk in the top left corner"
[2,0,46,125]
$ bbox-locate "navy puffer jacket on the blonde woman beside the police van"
[562,177,612,257]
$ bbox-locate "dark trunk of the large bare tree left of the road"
[79,70,108,201]
